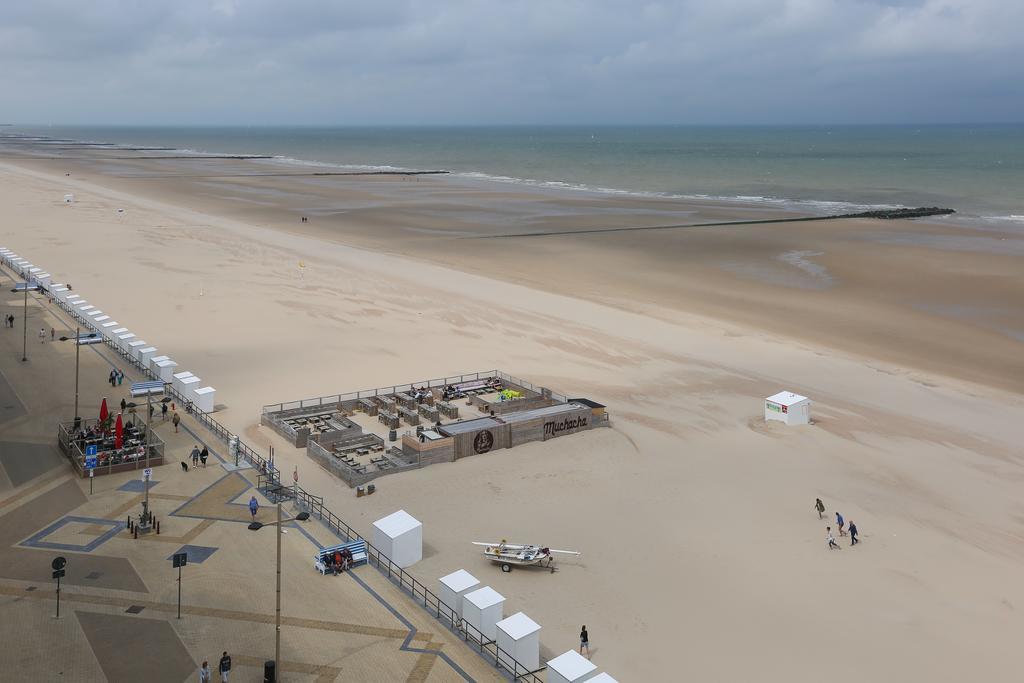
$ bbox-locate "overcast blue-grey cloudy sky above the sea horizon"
[0,0,1024,125]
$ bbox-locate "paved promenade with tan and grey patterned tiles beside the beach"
[0,264,501,683]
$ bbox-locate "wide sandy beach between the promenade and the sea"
[0,146,1024,681]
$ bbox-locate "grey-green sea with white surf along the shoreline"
[8,125,1024,225]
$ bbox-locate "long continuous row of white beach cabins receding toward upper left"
[0,247,217,413]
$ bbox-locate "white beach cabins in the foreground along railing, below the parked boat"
[374,510,615,683]
